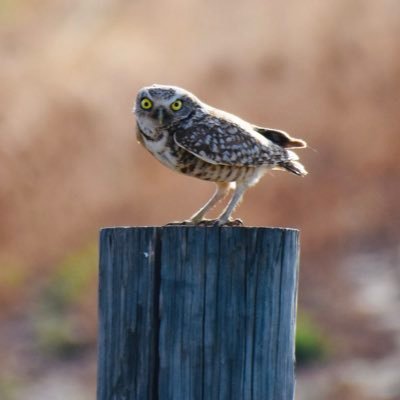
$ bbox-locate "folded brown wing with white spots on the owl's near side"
[174,118,289,166]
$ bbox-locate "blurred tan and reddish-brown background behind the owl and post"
[0,0,400,400]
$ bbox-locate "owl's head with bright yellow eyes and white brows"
[133,85,201,132]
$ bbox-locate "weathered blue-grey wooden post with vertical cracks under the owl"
[97,226,299,400]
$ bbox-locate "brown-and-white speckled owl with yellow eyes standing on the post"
[134,85,307,225]
